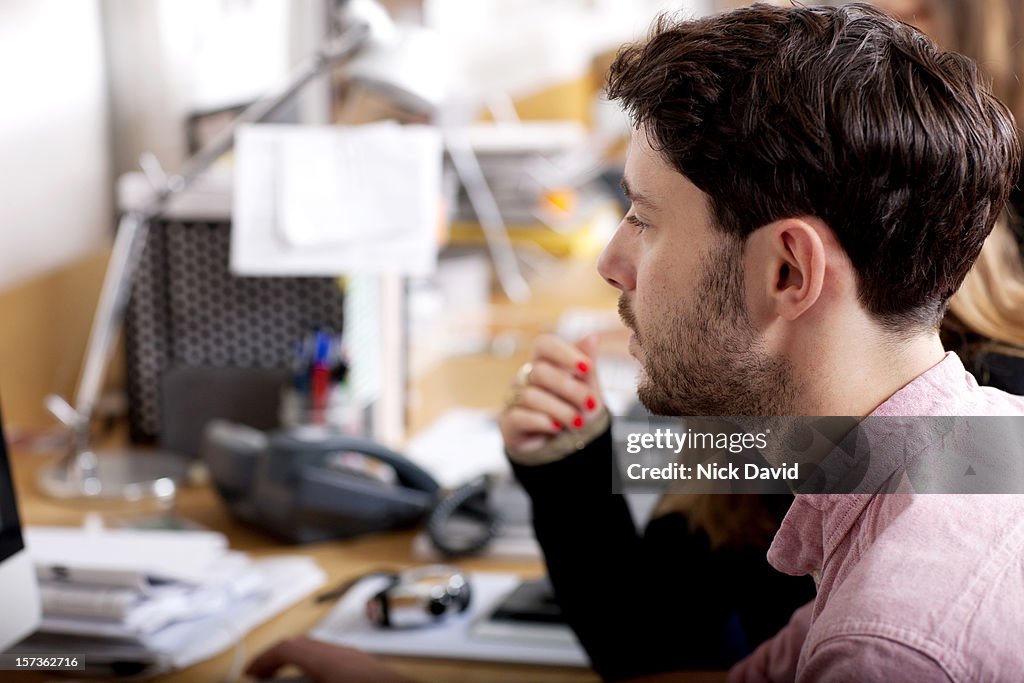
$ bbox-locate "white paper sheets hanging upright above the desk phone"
[230,123,442,276]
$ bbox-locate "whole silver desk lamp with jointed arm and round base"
[40,0,471,501]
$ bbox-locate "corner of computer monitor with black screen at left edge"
[0,405,42,652]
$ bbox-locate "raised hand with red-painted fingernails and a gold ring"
[498,335,603,456]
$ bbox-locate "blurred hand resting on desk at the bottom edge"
[246,637,414,683]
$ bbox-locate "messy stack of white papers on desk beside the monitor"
[12,527,325,675]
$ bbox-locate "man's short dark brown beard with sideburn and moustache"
[618,237,797,417]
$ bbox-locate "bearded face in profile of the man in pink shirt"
[598,129,792,416]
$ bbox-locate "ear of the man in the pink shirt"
[761,218,828,321]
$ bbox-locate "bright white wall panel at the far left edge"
[0,0,113,289]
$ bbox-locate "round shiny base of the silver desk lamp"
[39,450,189,502]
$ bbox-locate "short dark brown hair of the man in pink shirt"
[607,4,1021,331]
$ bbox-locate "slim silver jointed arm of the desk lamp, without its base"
[62,24,370,436]
